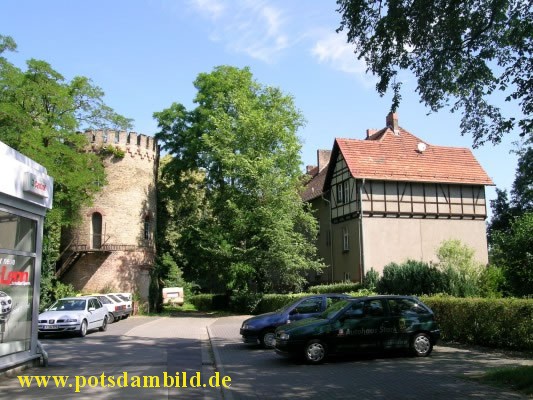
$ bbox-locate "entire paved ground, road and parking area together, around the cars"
[0,316,533,400]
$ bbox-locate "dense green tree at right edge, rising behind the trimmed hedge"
[491,211,533,296]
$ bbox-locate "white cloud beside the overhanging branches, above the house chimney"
[311,33,366,77]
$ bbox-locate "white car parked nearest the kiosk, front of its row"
[39,296,108,336]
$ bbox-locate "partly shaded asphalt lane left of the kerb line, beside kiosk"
[0,317,222,400]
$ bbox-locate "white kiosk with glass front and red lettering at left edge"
[0,142,53,372]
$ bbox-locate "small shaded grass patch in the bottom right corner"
[478,365,533,396]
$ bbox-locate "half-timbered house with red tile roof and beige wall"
[302,114,493,282]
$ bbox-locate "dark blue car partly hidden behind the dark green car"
[241,293,349,347]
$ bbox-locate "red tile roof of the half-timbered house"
[334,127,494,185]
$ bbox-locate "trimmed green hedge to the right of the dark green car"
[421,296,533,351]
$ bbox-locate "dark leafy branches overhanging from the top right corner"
[337,0,533,146]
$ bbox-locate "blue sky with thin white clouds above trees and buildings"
[0,0,519,216]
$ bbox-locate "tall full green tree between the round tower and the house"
[154,66,320,292]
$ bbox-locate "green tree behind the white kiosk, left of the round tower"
[0,35,131,304]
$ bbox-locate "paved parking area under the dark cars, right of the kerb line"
[209,317,533,400]
